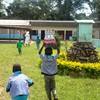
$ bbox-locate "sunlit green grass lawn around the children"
[0,43,100,100]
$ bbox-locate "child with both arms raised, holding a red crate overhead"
[39,44,60,100]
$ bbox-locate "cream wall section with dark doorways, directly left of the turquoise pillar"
[31,26,76,40]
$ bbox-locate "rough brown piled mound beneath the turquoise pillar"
[67,42,98,63]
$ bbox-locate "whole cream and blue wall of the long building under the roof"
[0,26,100,40]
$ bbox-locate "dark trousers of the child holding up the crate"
[44,75,56,100]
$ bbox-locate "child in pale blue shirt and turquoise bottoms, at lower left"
[6,64,34,100]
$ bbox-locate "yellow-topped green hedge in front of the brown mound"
[57,52,100,78]
